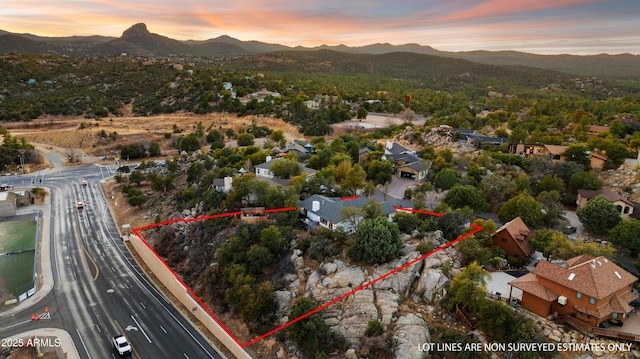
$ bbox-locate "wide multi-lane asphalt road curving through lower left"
[0,162,222,359]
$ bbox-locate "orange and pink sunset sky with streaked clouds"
[0,0,640,55]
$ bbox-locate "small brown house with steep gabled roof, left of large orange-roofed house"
[491,217,533,258]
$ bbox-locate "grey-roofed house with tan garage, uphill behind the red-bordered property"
[382,141,431,182]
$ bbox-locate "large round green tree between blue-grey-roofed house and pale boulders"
[351,217,402,263]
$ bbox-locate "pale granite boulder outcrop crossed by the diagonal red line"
[276,245,460,358]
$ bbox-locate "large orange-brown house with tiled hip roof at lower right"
[509,254,638,326]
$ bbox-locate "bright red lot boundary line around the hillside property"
[133,207,482,348]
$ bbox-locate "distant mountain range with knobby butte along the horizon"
[0,23,640,78]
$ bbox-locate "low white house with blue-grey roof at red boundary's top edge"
[299,194,396,233]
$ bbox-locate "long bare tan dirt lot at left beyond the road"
[4,107,304,168]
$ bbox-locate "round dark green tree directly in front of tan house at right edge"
[576,196,622,234]
